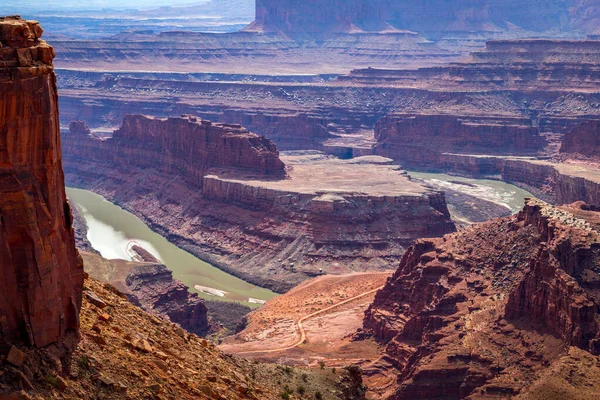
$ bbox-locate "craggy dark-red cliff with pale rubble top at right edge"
[505,202,600,354]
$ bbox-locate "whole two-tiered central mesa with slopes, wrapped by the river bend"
[64,116,455,292]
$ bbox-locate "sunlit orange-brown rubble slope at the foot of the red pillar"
[0,278,361,400]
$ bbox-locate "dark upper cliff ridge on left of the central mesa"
[64,115,286,181]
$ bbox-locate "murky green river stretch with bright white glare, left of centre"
[67,188,276,307]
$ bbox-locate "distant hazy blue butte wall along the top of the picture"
[246,0,598,39]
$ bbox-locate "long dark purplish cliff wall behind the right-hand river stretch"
[375,115,544,156]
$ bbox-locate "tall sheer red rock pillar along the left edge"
[0,17,83,347]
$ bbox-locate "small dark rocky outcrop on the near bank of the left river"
[125,264,209,335]
